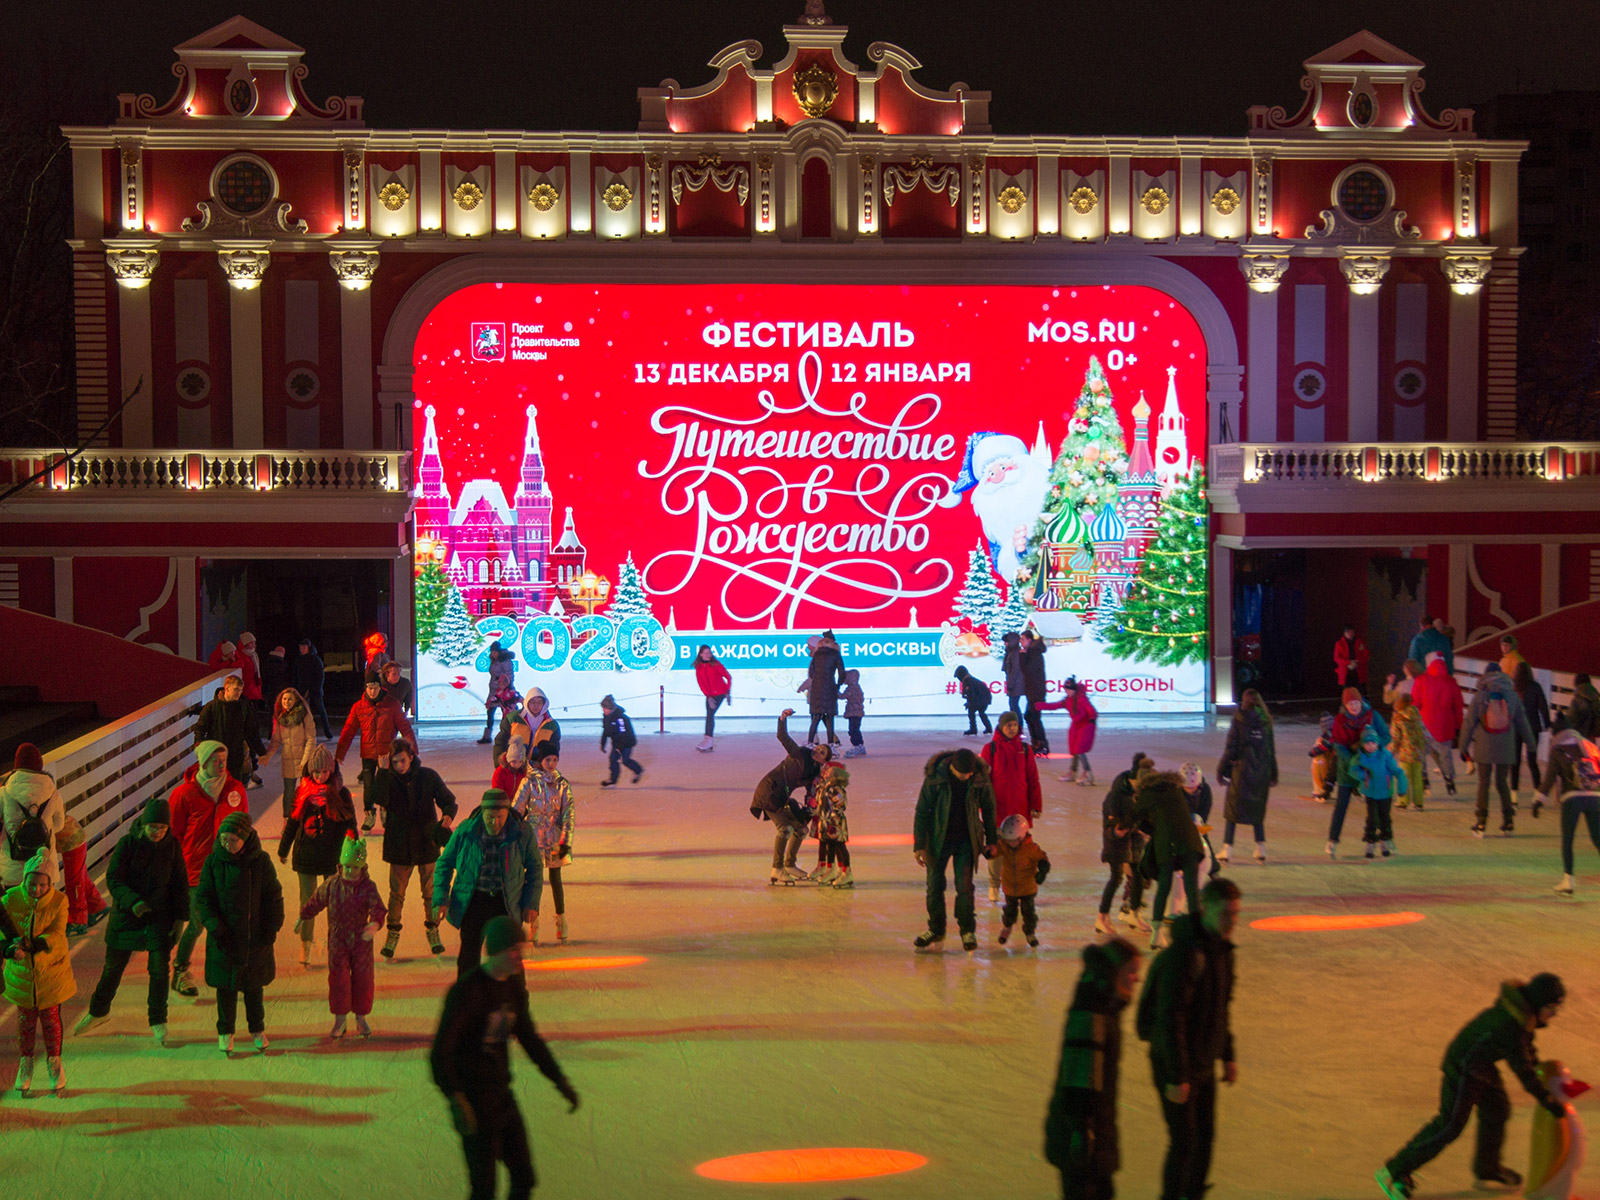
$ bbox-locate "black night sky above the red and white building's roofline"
[0,0,1600,136]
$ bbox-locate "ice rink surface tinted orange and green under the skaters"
[0,715,1600,1200]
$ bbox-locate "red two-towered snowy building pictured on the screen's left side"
[416,405,584,618]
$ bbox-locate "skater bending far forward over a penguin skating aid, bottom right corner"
[1378,973,1566,1200]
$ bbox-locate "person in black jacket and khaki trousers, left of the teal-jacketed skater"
[373,738,456,958]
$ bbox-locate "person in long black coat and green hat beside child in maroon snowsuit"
[194,813,283,1054]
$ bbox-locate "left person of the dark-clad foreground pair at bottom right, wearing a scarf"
[1045,938,1139,1200]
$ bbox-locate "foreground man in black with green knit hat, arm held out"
[429,914,578,1197]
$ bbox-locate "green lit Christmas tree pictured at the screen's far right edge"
[1096,466,1208,667]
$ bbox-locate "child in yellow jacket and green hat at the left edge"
[3,850,78,1096]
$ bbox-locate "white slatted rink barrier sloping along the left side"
[45,670,237,877]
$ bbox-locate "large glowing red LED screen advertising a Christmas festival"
[414,283,1208,718]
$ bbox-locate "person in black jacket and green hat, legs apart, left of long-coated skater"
[72,797,189,1045]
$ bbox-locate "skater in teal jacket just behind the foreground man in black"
[434,787,544,978]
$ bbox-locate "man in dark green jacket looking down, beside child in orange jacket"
[912,749,998,950]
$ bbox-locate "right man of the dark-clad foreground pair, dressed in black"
[1136,877,1240,1200]
